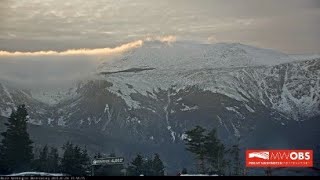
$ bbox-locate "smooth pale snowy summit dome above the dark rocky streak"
[100,41,292,72]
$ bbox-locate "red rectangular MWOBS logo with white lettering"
[246,150,313,167]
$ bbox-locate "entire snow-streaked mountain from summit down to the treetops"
[0,42,320,143]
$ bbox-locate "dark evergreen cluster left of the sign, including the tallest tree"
[0,105,90,175]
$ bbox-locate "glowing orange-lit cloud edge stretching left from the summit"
[0,40,143,57]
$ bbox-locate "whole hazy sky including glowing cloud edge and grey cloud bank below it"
[0,0,320,90]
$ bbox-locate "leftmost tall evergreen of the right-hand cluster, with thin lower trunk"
[185,126,207,173]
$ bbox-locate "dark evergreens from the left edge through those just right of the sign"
[0,105,165,176]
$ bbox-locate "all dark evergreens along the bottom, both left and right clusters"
[0,105,241,176]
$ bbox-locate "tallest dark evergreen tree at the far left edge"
[0,105,33,173]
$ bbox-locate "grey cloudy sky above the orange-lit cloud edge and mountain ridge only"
[0,0,320,53]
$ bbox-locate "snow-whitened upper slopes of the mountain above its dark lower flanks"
[99,42,320,120]
